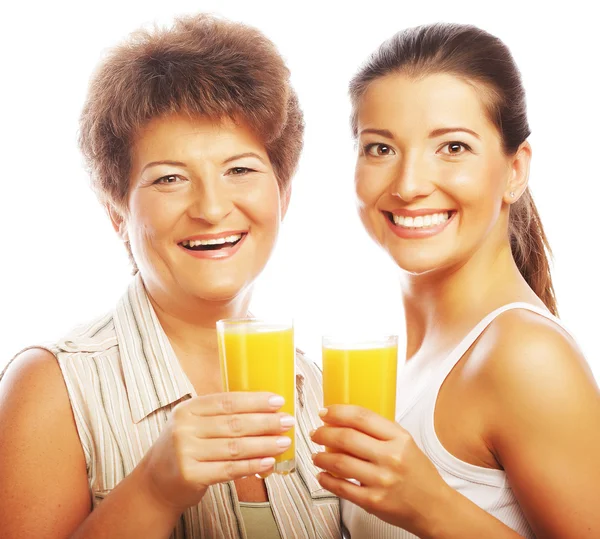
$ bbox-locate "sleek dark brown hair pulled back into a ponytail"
[350,23,557,314]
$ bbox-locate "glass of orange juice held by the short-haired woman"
[217,318,296,477]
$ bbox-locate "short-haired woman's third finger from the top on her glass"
[186,436,292,462]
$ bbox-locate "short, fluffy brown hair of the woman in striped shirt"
[79,14,304,215]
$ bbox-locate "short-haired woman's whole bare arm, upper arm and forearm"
[0,349,178,539]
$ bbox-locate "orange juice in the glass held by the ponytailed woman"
[323,336,398,421]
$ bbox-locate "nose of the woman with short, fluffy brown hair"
[188,173,234,225]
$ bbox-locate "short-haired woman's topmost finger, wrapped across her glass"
[184,391,285,416]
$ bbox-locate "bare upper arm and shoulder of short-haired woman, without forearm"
[0,348,90,537]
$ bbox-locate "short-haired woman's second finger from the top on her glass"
[195,413,295,438]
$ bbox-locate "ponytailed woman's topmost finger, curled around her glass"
[319,404,404,440]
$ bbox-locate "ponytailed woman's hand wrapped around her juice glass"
[312,404,451,536]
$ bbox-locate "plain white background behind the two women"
[0,0,600,379]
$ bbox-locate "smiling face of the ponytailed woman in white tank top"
[356,74,514,274]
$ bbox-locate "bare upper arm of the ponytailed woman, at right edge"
[484,312,600,539]
